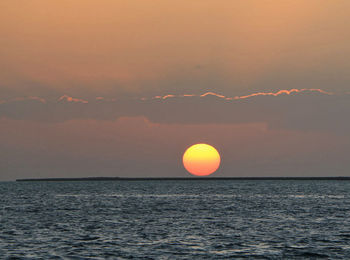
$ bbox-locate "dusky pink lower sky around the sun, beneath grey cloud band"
[0,118,350,179]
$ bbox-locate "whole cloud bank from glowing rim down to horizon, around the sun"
[0,90,350,179]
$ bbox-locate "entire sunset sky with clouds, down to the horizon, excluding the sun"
[0,0,350,180]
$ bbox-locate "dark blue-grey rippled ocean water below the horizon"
[0,180,350,259]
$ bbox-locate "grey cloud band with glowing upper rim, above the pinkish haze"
[0,89,350,134]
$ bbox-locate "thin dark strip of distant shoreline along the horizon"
[16,176,350,182]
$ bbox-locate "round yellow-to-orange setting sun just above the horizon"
[182,144,221,176]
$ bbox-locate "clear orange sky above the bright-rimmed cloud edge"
[0,0,350,97]
